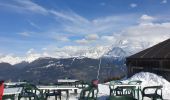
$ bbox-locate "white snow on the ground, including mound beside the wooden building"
[98,72,170,100]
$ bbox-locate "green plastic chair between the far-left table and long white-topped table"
[18,84,45,100]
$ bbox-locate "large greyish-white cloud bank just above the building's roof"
[121,19,170,45]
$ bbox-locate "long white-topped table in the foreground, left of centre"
[37,85,79,99]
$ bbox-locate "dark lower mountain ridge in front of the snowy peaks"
[0,57,125,83]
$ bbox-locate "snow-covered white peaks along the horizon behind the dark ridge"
[0,40,151,65]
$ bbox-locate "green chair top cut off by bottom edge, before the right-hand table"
[107,96,137,100]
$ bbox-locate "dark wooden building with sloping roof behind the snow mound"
[126,39,170,81]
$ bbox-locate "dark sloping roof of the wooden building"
[128,39,170,59]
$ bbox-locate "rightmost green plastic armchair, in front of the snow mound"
[142,86,163,100]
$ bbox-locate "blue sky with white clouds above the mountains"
[0,0,170,56]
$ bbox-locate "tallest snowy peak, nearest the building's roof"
[103,40,151,58]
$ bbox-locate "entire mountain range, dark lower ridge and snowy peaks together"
[0,41,153,83]
